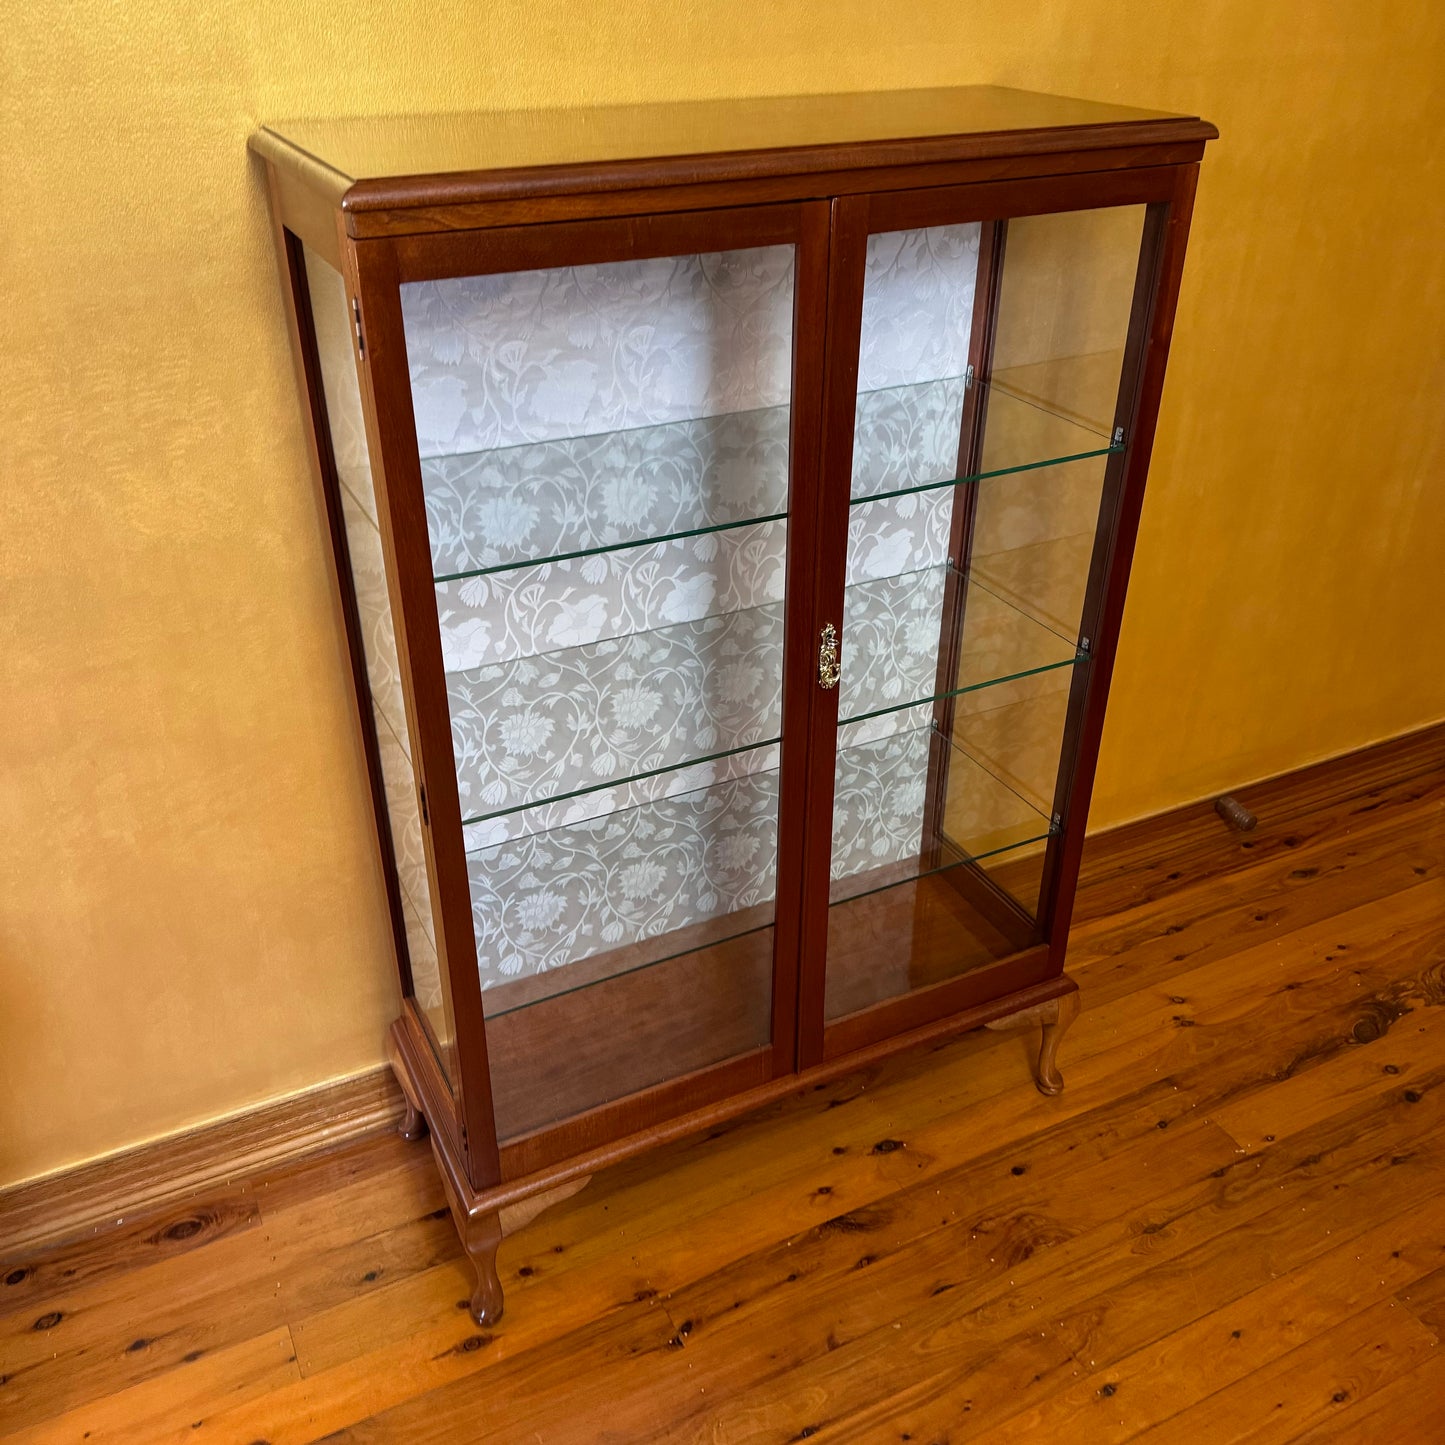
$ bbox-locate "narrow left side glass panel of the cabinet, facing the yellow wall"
[306,250,457,1087]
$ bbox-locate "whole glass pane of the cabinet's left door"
[402,246,793,1140]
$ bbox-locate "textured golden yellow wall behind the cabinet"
[0,0,1445,1183]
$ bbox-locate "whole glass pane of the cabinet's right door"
[825,207,1143,1020]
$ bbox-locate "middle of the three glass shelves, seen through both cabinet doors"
[448,565,1082,828]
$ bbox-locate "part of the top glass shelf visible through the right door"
[850,377,1124,507]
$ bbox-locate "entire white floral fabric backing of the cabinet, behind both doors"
[403,225,1051,985]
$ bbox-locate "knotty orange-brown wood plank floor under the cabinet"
[0,730,1445,1445]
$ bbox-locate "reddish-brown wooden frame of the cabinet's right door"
[799,163,1198,1069]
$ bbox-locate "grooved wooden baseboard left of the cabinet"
[0,1064,405,1264]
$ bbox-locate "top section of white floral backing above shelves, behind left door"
[402,246,793,457]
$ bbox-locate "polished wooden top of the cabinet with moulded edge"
[251,85,1215,210]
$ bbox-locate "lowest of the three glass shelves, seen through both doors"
[467,725,1049,1019]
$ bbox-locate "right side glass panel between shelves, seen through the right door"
[952,205,1144,913]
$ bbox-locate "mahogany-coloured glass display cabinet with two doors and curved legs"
[251,90,1215,1321]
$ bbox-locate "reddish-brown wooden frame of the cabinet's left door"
[342,201,828,1189]
